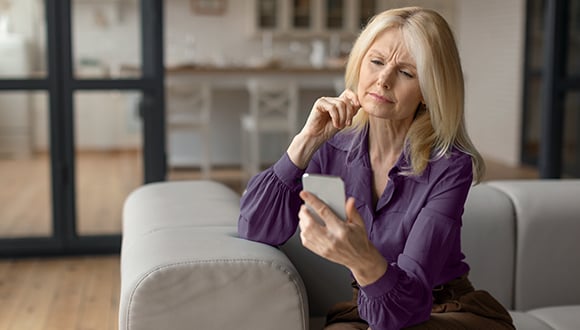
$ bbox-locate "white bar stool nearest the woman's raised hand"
[241,78,298,181]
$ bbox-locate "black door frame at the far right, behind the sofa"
[521,0,580,179]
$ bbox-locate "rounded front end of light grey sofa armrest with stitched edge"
[119,226,308,330]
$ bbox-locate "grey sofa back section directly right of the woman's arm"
[461,183,515,308]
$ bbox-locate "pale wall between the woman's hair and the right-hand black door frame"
[456,0,525,165]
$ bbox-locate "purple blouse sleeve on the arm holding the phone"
[358,157,472,330]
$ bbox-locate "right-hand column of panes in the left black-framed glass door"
[71,0,143,237]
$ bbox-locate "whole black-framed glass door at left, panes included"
[0,0,165,256]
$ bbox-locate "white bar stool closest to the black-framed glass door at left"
[165,81,212,179]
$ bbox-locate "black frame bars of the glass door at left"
[0,0,166,257]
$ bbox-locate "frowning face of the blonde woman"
[357,28,422,121]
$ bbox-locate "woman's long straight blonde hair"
[345,7,485,182]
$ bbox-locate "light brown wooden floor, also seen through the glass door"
[0,153,537,330]
